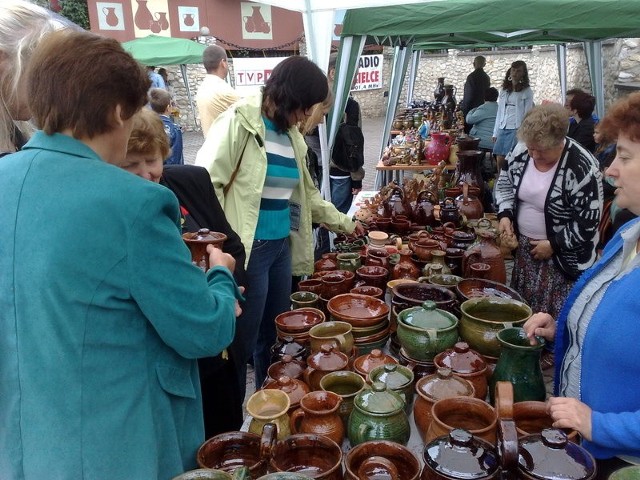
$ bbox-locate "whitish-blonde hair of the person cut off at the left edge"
[0,0,63,152]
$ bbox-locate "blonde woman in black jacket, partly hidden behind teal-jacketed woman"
[117,109,247,438]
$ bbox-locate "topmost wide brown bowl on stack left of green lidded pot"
[327,293,389,327]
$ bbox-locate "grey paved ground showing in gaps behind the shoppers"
[183,117,384,190]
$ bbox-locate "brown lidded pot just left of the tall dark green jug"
[433,342,487,400]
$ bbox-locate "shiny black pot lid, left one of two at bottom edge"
[422,428,499,479]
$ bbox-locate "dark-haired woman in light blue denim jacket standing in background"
[493,60,533,172]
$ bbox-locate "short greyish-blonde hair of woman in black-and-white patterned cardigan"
[518,103,569,148]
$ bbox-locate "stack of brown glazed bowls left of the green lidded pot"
[327,293,389,354]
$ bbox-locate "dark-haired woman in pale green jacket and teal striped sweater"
[196,56,362,388]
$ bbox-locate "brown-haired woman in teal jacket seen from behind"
[0,31,236,480]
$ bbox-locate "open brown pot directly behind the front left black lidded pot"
[426,397,498,445]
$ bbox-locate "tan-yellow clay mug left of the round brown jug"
[247,389,291,439]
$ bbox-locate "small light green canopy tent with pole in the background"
[122,35,207,127]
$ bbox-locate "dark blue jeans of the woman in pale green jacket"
[232,238,291,398]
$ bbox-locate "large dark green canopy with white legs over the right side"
[338,0,640,188]
